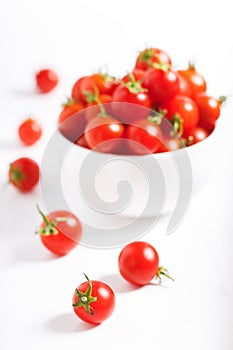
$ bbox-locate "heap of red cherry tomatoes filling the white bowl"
[58,48,225,155]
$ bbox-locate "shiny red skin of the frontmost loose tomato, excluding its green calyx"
[72,281,115,324]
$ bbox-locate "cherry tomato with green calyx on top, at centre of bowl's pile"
[112,75,152,123]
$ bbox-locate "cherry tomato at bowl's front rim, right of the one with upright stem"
[125,119,163,155]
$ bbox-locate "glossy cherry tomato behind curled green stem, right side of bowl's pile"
[161,95,199,137]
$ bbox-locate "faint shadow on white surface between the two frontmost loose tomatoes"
[101,273,141,293]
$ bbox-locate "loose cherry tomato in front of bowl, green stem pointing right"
[118,242,172,286]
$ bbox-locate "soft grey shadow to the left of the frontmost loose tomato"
[47,313,98,333]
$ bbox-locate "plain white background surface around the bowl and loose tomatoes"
[0,0,233,350]
